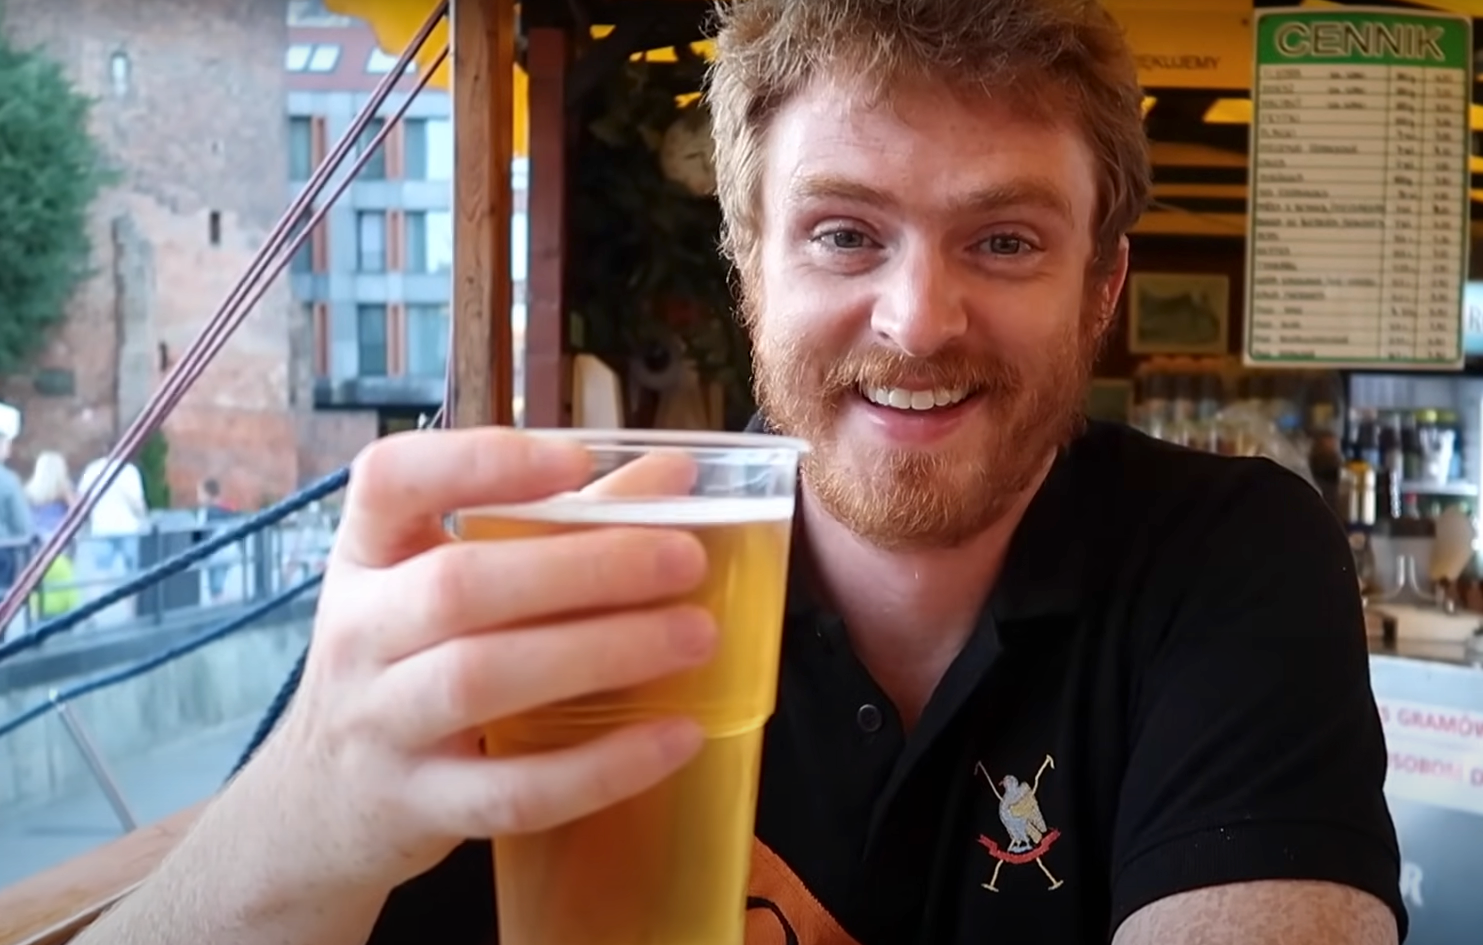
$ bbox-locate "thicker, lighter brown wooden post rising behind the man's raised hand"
[449,0,515,427]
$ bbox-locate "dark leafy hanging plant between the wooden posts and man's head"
[568,49,752,415]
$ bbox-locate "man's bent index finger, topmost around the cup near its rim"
[335,427,592,568]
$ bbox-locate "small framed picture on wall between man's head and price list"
[1127,273,1231,355]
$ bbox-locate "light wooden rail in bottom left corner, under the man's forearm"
[0,803,205,945]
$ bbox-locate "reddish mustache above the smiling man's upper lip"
[823,349,1025,398]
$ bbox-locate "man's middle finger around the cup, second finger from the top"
[360,528,706,663]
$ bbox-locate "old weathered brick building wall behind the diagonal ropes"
[3,0,313,504]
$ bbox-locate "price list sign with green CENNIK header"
[1246,9,1473,369]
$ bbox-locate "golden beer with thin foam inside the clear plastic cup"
[460,495,793,945]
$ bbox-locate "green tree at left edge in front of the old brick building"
[0,20,113,377]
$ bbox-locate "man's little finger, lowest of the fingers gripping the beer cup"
[408,720,703,837]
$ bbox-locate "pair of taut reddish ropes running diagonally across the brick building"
[0,0,448,626]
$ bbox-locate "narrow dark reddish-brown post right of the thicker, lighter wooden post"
[525,27,572,427]
